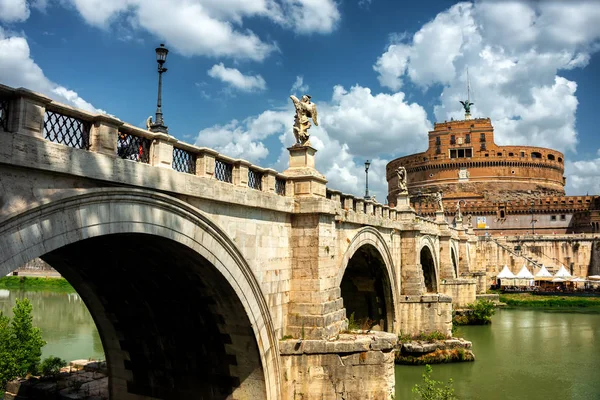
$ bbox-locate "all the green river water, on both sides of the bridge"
[0,290,600,400]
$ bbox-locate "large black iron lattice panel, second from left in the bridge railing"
[44,110,92,150]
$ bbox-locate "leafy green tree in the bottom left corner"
[0,298,46,387]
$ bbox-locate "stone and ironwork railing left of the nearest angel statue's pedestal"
[0,85,293,196]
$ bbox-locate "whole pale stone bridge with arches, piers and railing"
[0,85,483,400]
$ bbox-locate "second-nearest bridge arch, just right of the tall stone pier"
[336,227,400,332]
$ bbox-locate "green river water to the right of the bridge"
[396,310,600,400]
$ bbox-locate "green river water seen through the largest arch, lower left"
[0,290,104,361]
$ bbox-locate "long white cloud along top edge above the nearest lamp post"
[63,0,340,61]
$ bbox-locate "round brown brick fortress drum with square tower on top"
[386,118,565,204]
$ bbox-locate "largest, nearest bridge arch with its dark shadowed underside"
[0,188,281,400]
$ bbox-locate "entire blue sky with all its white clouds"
[0,0,600,202]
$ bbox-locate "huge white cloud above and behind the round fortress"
[373,1,600,151]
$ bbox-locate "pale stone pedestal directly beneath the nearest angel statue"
[283,145,327,197]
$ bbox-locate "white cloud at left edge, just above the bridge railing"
[0,27,104,113]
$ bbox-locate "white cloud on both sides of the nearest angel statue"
[196,85,431,203]
